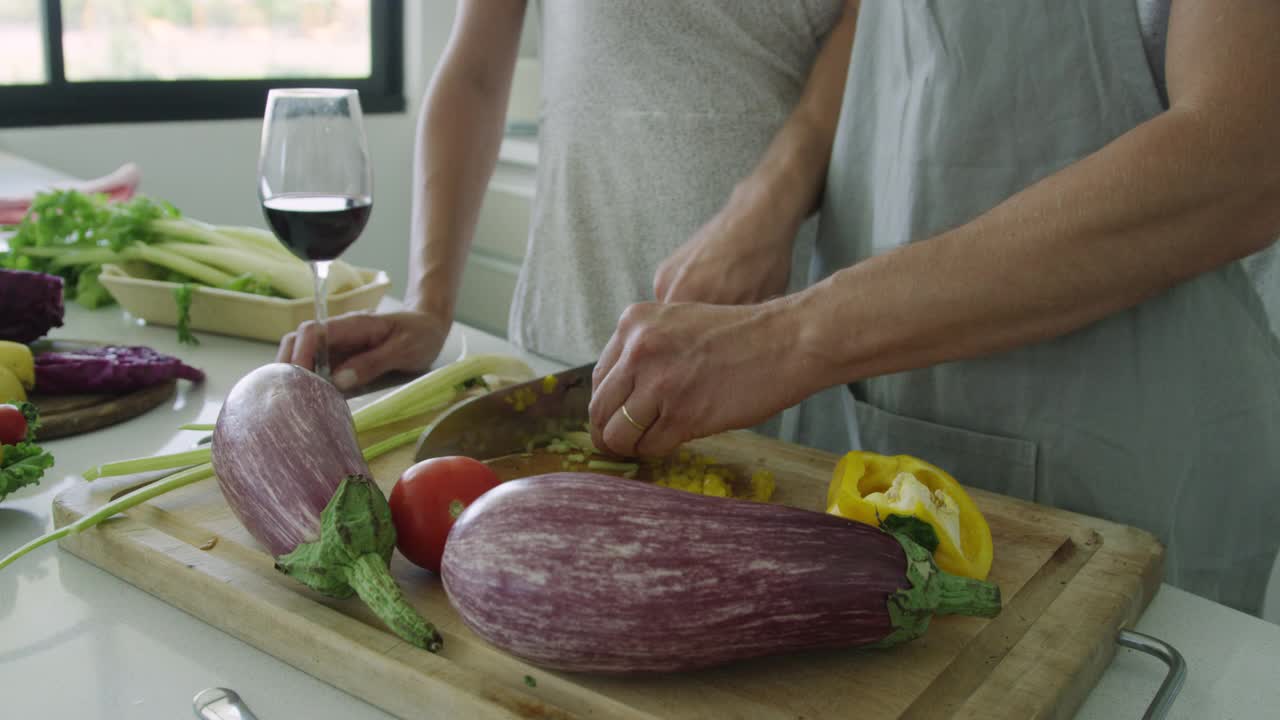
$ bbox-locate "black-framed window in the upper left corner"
[0,0,404,127]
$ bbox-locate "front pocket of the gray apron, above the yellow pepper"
[854,398,1037,500]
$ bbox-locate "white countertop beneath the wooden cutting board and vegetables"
[0,152,1280,720]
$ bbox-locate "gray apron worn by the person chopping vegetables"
[817,0,1280,615]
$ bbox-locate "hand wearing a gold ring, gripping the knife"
[590,300,818,456]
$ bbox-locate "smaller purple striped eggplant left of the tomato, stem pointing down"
[212,363,440,652]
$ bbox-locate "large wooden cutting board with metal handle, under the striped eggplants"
[54,417,1162,720]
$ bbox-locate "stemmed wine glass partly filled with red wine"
[257,88,374,379]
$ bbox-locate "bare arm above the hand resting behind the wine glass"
[404,0,524,318]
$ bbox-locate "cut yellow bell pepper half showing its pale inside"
[827,451,992,580]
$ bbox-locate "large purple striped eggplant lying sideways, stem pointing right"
[442,473,1000,673]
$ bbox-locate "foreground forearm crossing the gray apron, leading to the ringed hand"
[794,103,1280,387]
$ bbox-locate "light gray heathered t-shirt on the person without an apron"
[508,0,845,364]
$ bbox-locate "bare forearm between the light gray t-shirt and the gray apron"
[730,1,858,233]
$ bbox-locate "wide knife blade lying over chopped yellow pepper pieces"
[413,363,595,462]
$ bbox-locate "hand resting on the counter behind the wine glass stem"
[275,310,452,389]
